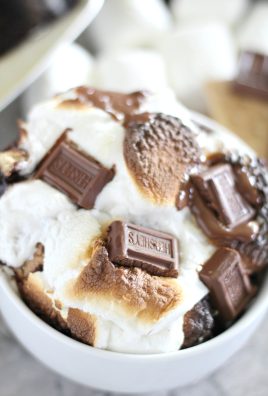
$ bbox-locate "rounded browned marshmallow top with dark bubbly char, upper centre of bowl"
[124,114,200,205]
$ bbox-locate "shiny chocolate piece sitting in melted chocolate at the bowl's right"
[192,164,255,228]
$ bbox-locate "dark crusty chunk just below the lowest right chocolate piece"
[182,297,215,348]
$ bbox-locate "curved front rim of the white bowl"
[0,270,268,362]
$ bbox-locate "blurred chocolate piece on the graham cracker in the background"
[234,51,268,99]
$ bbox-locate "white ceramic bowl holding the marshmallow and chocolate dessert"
[0,114,268,393]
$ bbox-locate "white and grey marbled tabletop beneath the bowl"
[0,100,268,396]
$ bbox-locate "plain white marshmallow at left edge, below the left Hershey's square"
[0,180,75,267]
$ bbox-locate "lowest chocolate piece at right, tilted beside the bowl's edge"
[199,248,255,321]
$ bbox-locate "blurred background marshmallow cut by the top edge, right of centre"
[171,0,249,25]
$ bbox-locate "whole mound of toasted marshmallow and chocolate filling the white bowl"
[0,87,268,354]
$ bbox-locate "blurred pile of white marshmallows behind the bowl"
[24,0,268,113]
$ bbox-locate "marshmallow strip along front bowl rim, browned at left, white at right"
[20,272,183,354]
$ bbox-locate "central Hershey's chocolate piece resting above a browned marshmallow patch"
[108,221,179,278]
